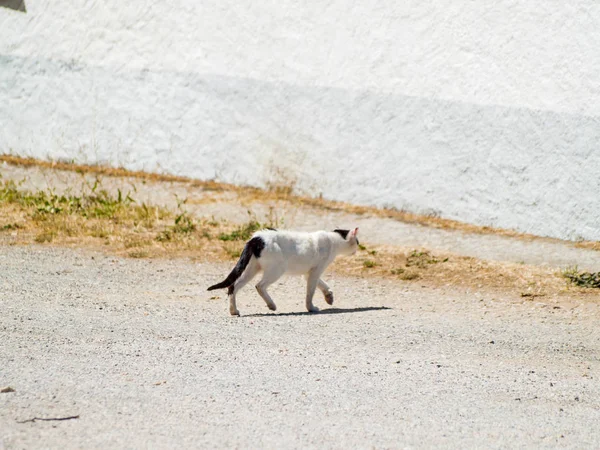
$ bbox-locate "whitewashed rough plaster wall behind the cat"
[0,0,600,240]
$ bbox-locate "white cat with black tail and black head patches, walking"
[208,228,359,316]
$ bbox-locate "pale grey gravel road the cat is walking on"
[0,246,600,449]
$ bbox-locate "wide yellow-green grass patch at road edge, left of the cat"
[0,174,273,260]
